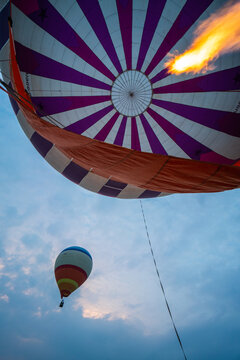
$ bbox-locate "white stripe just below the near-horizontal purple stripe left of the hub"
[43,101,111,127]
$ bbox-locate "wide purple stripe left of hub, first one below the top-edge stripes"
[15,41,111,90]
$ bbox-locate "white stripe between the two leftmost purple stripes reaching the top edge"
[50,0,117,76]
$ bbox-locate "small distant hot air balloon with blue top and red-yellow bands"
[54,246,92,307]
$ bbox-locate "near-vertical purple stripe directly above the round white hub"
[116,0,133,70]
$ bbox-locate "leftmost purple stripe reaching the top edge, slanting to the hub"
[13,0,115,80]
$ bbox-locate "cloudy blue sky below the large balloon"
[0,87,240,360]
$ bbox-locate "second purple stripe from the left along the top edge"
[77,0,122,73]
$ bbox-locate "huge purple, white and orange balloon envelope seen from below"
[0,0,240,198]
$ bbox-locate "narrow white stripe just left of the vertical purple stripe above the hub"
[99,0,127,71]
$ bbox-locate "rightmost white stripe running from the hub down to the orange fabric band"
[144,110,190,159]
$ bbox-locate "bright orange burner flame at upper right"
[165,1,240,75]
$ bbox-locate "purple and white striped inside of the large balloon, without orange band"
[0,0,240,197]
